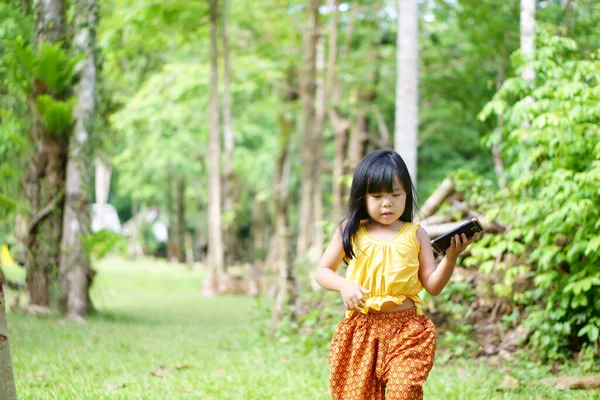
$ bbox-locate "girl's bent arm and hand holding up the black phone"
[417,227,475,296]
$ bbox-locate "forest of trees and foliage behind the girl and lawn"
[0,0,600,398]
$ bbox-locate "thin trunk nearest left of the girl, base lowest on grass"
[273,68,298,330]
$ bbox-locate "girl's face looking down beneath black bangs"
[367,176,406,225]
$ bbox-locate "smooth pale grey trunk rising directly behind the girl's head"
[394,0,419,186]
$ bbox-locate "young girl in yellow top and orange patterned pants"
[315,150,473,400]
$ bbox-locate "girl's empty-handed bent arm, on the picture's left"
[315,230,370,310]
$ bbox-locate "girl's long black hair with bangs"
[340,150,416,260]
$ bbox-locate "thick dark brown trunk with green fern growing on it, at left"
[23,0,68,307]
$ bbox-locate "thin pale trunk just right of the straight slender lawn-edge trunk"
[221,0,237,262]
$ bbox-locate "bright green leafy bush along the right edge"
[471,29,600,359]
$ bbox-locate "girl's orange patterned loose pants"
[329,308,435,400]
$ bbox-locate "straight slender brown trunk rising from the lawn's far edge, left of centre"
[208,0,225,293]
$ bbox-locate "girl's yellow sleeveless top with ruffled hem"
[346,222,423,316]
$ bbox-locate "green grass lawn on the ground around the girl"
[7,258,600,400]
